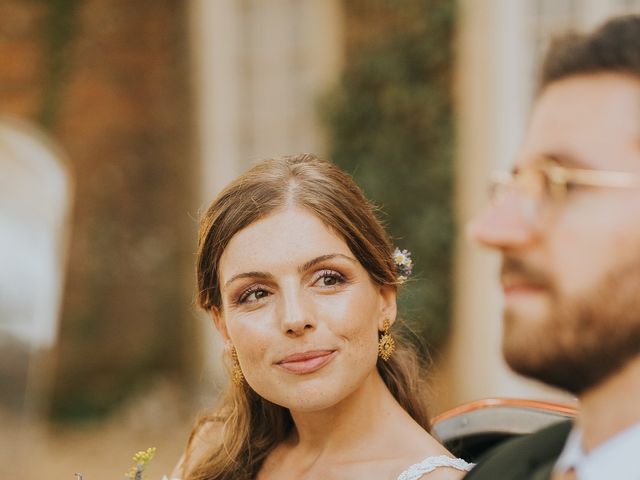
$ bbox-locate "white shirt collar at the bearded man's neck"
[553,423,640,480]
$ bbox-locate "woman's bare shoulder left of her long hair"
[171,415,223,479]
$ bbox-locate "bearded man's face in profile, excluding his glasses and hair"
[469,74,640,394]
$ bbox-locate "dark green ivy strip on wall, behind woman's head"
[323,0,456,348]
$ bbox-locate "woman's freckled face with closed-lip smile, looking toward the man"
[214,207,396,411]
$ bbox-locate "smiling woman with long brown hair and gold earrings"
[176,155,469,480]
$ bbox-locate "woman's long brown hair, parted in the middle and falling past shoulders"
[185,154,429,480]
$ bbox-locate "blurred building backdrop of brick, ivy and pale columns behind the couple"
[0,0,640,480]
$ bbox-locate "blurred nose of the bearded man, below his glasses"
[466,196,538,249]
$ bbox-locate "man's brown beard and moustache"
[502,256,640,395]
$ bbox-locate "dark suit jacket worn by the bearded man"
[464,421,571,480]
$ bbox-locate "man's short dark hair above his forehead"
[540,15,640,90]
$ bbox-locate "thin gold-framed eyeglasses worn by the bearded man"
[490,157,640,222]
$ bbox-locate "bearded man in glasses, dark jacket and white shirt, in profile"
[467,16,640,480]
